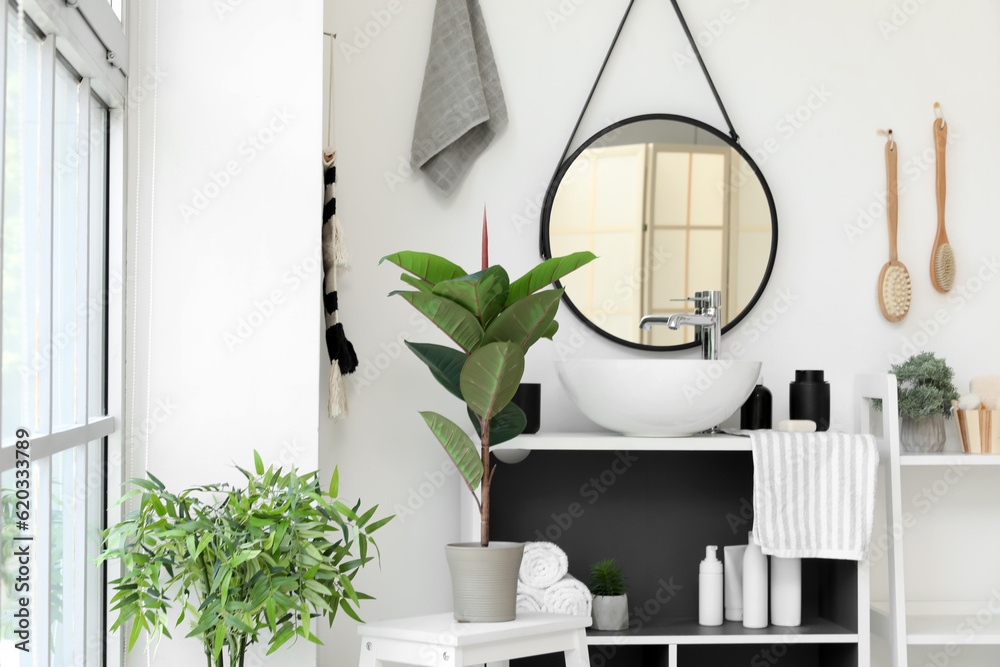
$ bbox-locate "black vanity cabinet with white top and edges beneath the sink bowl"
[491,434,869,667]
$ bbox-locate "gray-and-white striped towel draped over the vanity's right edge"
[748,431,878,560]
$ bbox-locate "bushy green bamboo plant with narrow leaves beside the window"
[98,452,392,667]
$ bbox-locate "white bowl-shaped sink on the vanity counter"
[556,359,760,437]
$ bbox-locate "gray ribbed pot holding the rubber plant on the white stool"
[444,542,524,623]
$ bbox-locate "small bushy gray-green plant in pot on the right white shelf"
[875,352,958,453]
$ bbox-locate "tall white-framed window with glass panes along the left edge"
[0,0,128,667]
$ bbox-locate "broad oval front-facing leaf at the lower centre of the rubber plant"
[461,342,524,419]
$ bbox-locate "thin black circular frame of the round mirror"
[539,114,778,352]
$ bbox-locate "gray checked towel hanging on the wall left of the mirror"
[410,0,507,195]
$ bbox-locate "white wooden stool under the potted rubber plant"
[358,612,590,667]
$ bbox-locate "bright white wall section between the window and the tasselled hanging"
[125,0,322,665]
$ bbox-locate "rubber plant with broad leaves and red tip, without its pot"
[379,214,596,547]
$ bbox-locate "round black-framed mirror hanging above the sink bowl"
[541,114,778,350]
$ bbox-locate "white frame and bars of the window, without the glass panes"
[0,0,130,667]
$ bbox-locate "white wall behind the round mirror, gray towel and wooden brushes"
[320,0,1000,666]
